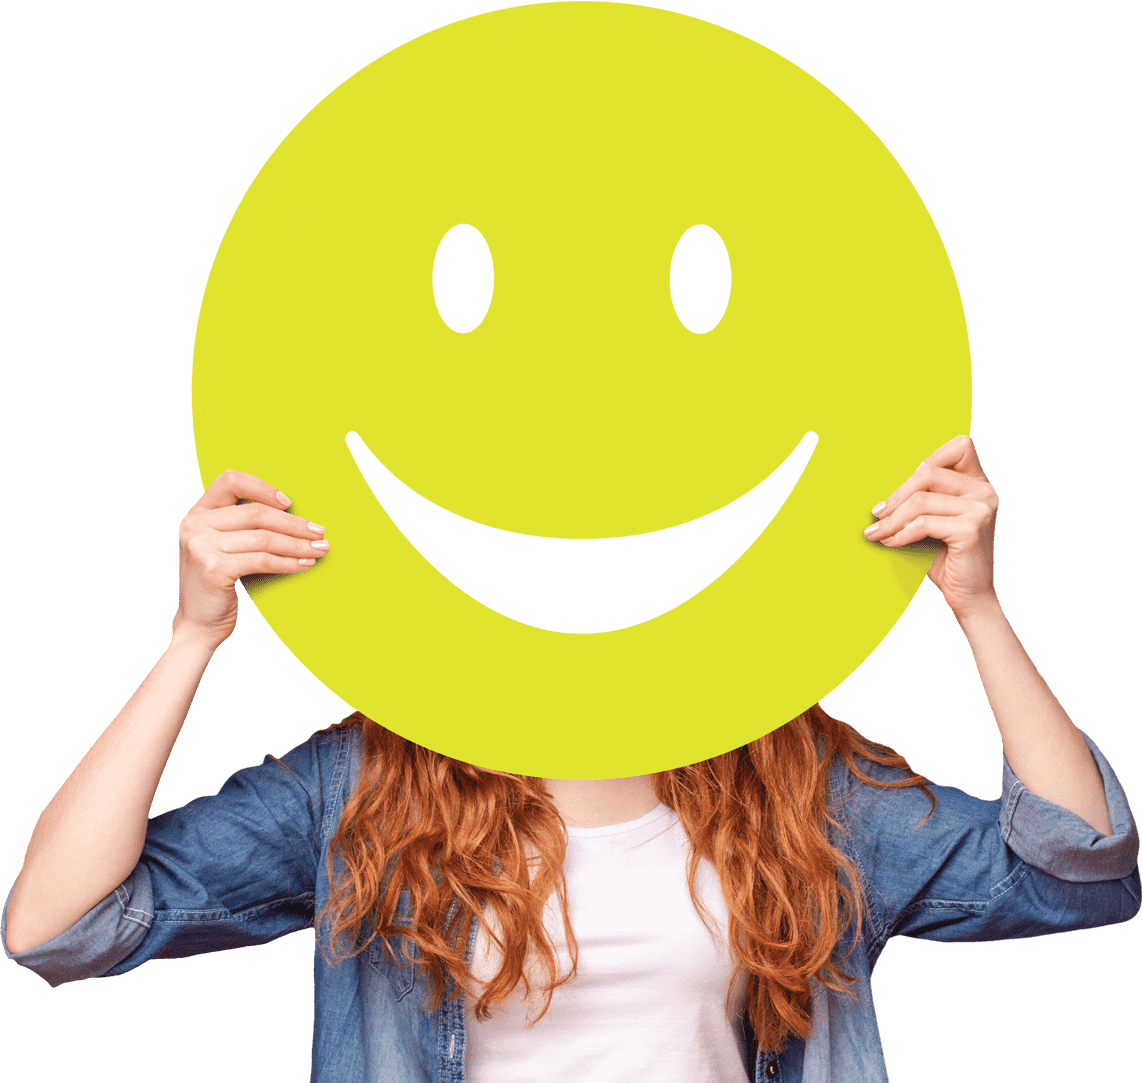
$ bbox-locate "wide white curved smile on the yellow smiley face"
[345,432,817,632]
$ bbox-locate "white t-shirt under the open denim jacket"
[465,804,750,1083]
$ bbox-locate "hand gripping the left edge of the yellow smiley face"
[171,470,328,649]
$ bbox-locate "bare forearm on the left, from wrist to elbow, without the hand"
[6,636,214,954]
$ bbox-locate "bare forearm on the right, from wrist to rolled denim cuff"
[958,600,1112,835]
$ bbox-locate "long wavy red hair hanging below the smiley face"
[315,704,936,1051]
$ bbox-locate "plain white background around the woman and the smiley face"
[5,3,1137,1083]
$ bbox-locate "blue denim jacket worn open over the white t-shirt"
[0,727,1140,1083]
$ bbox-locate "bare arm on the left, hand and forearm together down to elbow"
[5,470,323,955]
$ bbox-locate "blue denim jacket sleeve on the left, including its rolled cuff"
[2,728,349,988]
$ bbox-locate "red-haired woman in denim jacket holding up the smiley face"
[5,436,1140,1083]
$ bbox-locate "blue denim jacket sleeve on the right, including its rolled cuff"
[841,735,1140,945]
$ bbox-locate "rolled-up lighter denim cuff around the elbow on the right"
[1000,731,1140,883]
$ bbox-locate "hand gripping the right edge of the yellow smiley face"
[865,436,1000,620]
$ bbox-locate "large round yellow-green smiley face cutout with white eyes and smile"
[192,3,972,778]
